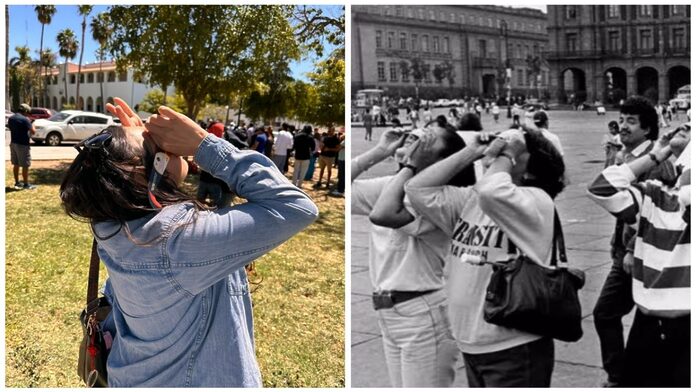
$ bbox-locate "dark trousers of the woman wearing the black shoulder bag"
[464,337,554,388]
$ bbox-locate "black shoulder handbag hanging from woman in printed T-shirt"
[483,210,585,342]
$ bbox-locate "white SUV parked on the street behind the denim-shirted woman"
[31,110,115,146]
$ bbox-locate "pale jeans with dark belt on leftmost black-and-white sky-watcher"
[377,290,459,388]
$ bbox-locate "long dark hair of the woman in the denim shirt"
[60,125,208,227]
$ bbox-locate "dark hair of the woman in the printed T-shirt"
[522,128,565,199]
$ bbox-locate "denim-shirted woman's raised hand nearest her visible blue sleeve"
[145,106,208,156]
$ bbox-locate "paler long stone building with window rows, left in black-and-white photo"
[351,5,549,99]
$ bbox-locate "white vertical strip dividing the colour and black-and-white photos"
[343,1,352,388]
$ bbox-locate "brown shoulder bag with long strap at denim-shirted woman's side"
[77,240,111,387]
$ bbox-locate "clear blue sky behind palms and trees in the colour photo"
[9,4,342,80]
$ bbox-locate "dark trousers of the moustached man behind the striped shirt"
[592,259,634,382]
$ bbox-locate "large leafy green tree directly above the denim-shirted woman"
[107,5,300,118]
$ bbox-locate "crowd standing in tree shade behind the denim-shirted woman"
[193,119,345,207]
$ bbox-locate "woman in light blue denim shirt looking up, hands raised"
[60,99,318,387]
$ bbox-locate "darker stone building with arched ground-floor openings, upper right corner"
[545,4,691,103]
